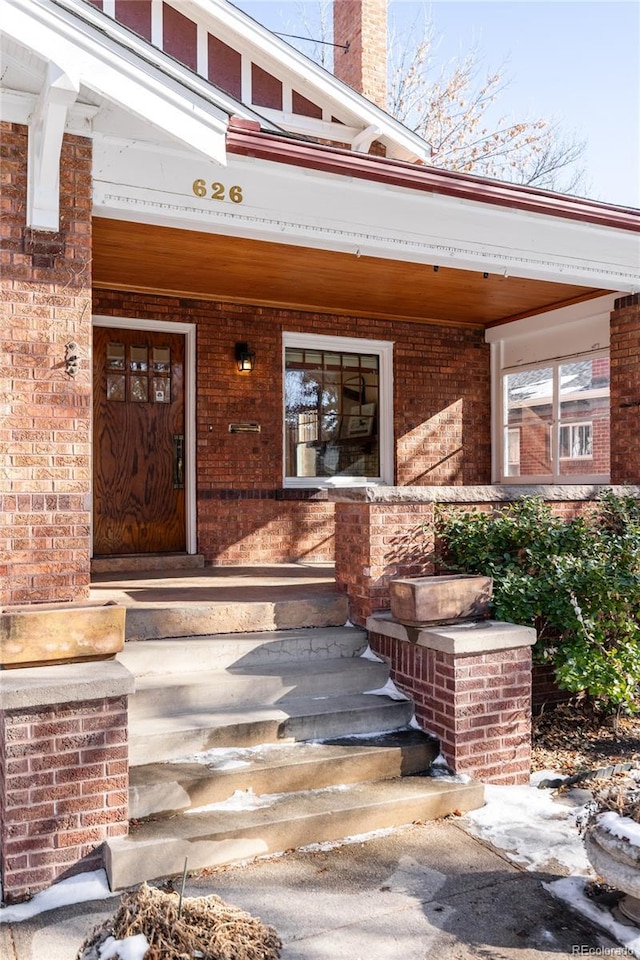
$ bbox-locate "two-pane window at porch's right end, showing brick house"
[501,353,610,483]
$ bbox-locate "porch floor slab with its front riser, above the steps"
[90,563,347,640]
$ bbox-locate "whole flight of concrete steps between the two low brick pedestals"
[109,627,483,889]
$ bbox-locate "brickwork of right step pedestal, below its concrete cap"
[369,633,531,784]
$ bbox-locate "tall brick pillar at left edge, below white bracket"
[0,123,92,604]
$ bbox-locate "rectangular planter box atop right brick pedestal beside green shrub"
[389,574,493,627]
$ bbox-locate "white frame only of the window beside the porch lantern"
[282,331,394,489]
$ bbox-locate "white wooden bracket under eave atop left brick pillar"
[27,63,80,231]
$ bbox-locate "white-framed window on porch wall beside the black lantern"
[283,333,393,487]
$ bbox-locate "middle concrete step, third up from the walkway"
[129,694,413,766]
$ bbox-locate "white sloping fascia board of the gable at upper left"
[0,0,228,164]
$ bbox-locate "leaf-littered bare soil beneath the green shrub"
[531,704,640,775]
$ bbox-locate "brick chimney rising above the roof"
[333,0,387,110]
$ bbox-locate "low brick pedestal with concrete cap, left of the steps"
[0,661,133,902]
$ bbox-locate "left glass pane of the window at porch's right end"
[503,367,553,477]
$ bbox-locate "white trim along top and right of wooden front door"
[92,315,198,554]
